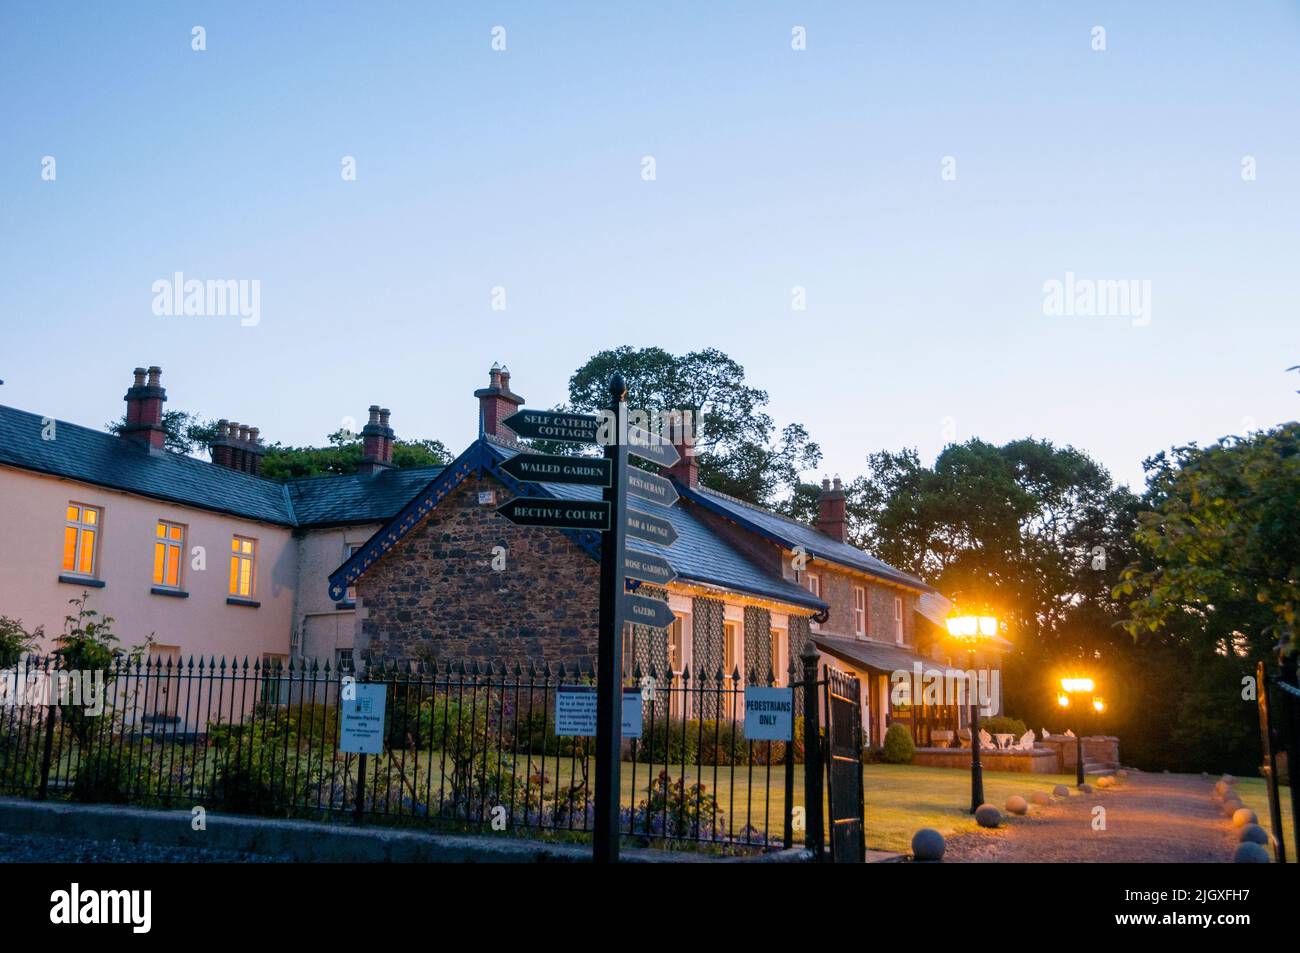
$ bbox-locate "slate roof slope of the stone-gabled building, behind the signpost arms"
[486,443,826,608]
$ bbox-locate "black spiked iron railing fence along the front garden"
[0,657,823,850]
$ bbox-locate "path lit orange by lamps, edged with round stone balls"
[944,774,1236,863]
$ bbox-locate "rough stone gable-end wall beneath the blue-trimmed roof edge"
[356,476,601,664]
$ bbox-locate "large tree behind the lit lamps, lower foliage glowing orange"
[845,438,1136,743]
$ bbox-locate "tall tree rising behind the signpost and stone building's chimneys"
[567,346,822,506]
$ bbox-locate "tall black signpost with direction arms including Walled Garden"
[497,374,681,863]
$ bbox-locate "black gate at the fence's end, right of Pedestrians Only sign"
[826,668,867,863]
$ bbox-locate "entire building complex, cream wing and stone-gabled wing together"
[0,367,996,742]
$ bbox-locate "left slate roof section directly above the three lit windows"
[0,407,296,525]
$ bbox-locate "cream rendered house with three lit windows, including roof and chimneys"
[0,368,441,664]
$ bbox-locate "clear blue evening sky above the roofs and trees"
[0,0,1300,491]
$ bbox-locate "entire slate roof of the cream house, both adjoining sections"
[0,407,442,527]
